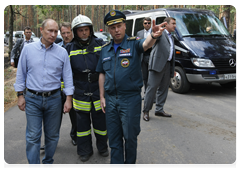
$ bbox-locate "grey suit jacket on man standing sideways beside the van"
[148,31,175,77]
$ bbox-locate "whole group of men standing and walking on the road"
[11,10,176,168]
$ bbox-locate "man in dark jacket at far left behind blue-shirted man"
[11,26,33,68]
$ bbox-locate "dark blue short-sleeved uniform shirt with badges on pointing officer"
[96,34,145,95]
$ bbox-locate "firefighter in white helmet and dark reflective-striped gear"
[66,15,109,162]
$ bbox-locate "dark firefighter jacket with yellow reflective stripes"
[66,36,105,112]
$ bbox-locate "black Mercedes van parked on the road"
[123,8,238,93]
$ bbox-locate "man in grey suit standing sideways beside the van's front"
[143,17,176,121]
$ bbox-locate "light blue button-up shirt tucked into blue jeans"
[14,40,74,95]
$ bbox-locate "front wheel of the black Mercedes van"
[170,66,190,93]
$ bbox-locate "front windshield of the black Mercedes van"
[169,12,230,37]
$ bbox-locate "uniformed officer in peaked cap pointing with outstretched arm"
[96,10,166,168]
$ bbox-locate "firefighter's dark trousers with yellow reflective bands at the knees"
[75,105,108,156]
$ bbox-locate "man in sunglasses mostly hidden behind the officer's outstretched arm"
[137,17,152,97]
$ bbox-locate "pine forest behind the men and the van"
[4,5,238,56]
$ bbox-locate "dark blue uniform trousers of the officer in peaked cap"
[105,93,142,168]
